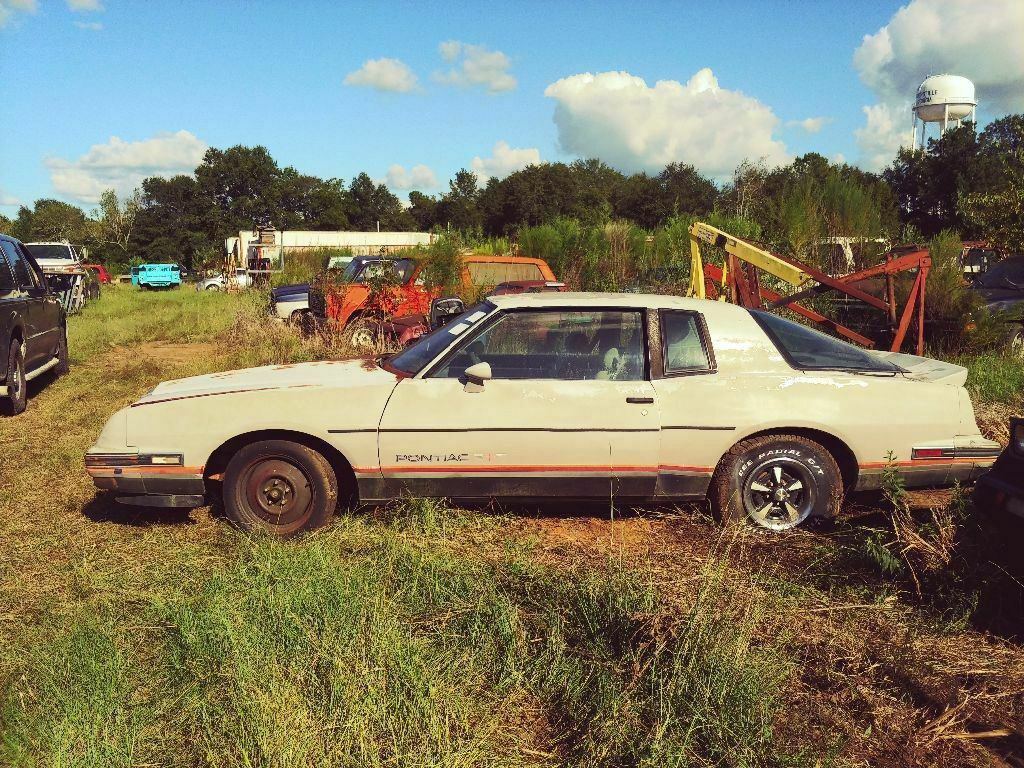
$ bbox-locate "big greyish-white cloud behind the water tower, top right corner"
[853,0,1024,170]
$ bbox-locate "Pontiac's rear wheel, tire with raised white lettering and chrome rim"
[708,434,843,530]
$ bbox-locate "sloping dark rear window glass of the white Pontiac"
[750,309,903,374]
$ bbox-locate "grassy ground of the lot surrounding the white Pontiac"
[0,287,1024,767]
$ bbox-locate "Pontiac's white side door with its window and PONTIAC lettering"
[379,308,659,499]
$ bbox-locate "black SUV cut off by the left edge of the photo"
[0,234,69,416]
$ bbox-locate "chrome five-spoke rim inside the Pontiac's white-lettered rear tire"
[743,458,814,530]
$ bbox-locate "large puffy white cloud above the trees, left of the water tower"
[544,69,788,179]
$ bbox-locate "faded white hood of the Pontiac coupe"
[133,358,397,406]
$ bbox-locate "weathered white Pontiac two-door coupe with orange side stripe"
[85,293,999,536]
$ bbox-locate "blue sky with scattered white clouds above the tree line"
[0,0,1024,216]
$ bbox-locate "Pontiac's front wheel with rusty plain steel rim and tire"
[223,440,338,539]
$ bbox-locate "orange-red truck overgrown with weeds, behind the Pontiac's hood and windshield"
[309,254,556,347]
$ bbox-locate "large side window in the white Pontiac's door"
[433,309,645,381]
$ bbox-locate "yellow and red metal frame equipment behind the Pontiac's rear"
[688,221,932,355]
